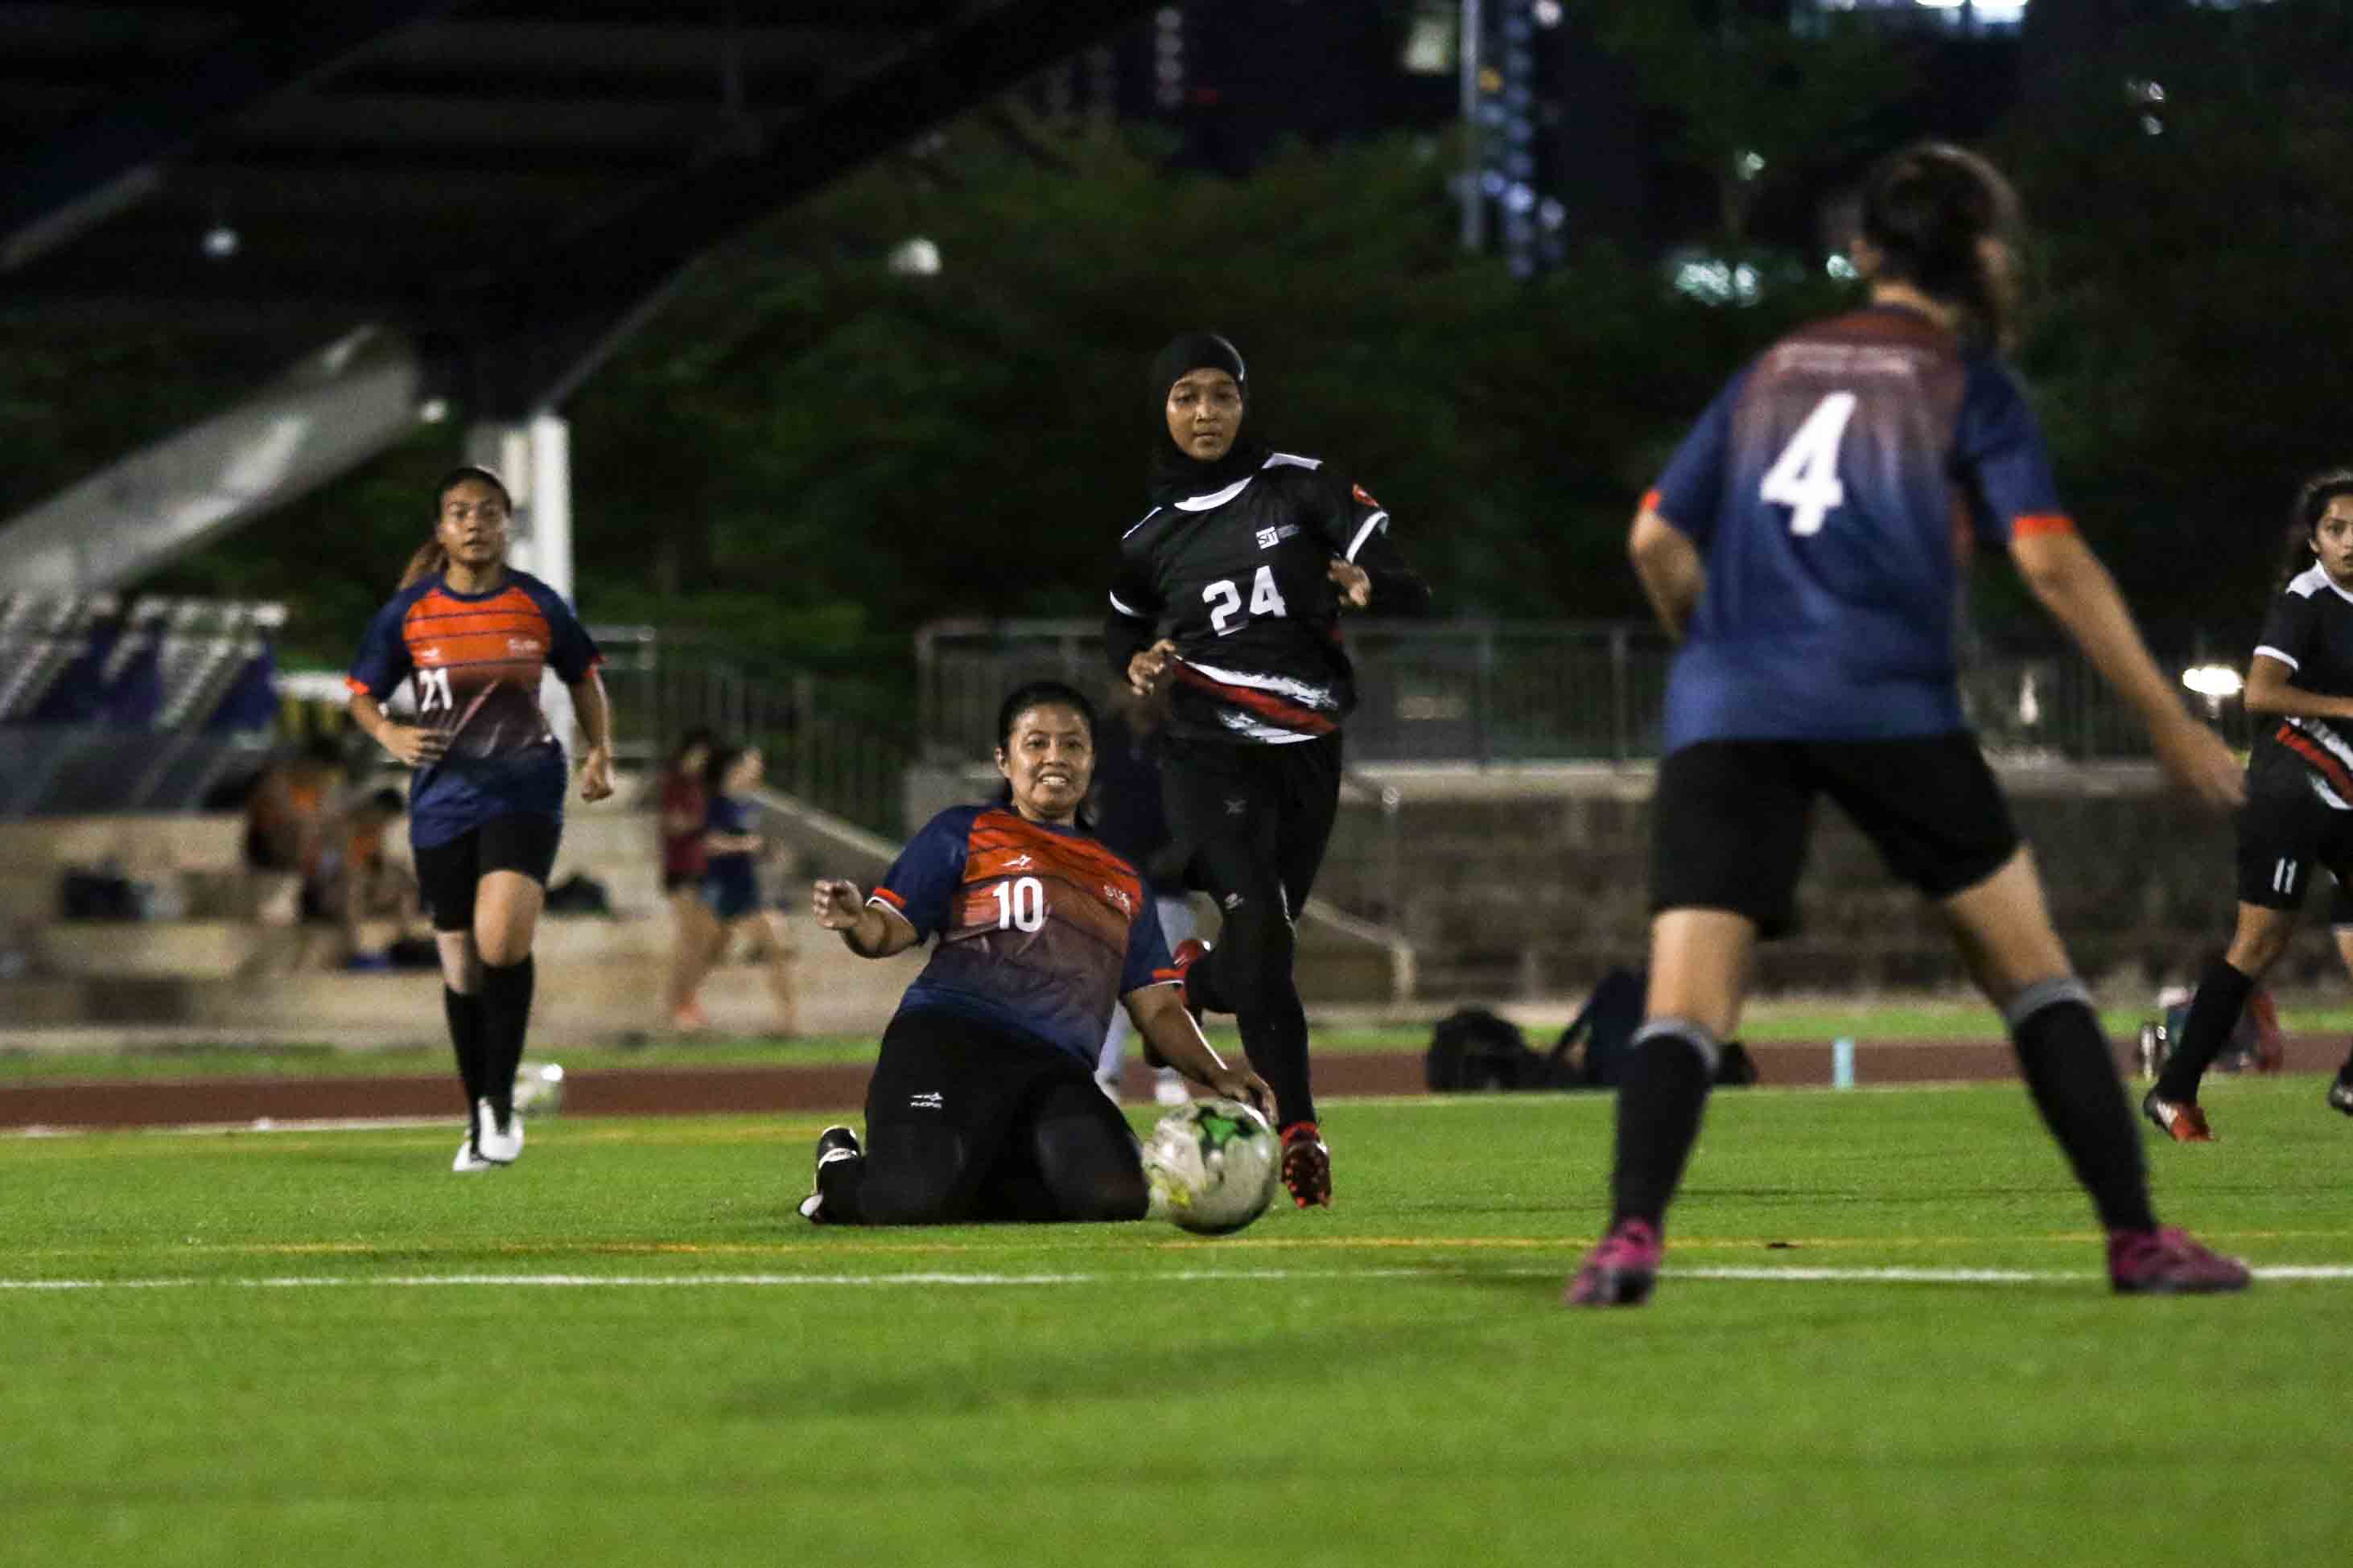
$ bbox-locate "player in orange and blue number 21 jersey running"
[351,466,612,1173]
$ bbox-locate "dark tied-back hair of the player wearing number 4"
[1861,141,2019,346]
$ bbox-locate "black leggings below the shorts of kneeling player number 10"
[817,1079,1148,1224]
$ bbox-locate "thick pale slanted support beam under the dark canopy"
[0,327,423,592]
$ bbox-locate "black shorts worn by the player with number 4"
[1650,729,2019,940]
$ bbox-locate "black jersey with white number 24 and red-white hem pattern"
[1103,451,1428,745]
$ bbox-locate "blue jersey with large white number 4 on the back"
[1645,306,2073,752]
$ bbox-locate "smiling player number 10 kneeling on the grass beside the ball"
[800,681,1273,1224]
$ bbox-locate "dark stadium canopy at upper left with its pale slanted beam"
[0,0,1148,590]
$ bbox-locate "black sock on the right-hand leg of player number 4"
[2009,980,2157,1229]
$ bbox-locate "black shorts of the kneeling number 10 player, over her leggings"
[866,1009,1134,1146]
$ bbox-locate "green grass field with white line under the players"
[0,1079,2353,1568]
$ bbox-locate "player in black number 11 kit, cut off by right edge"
[2141,467,2353,1142]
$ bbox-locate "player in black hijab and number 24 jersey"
[1103,331,1431,1208]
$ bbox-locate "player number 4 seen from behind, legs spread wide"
[1567,143,2249,1307]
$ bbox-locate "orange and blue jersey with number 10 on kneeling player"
[868,806,1179,1068]
